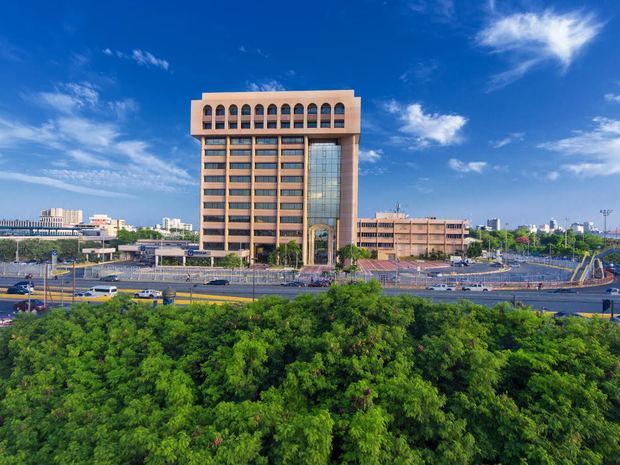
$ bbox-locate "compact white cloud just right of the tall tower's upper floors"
[386,100,467,147]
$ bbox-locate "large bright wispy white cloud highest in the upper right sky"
[477,10,602,88]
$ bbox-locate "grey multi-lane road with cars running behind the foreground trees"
[0,276,620,313]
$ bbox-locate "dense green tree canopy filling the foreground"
[0,283,620,465]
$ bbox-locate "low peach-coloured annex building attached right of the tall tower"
[357,212,469,260]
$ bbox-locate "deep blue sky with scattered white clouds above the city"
[0,0,620,231]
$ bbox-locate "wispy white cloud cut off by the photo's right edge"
[539,117,620,176]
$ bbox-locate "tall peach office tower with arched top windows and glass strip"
[191,90,361,264]
